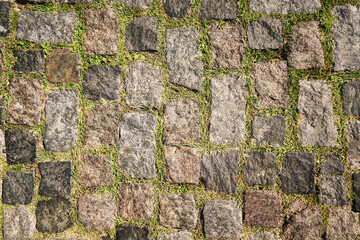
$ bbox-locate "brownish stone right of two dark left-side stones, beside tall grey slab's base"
[79,154,114,187]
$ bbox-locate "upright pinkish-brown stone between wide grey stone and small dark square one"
[84,8,119,55]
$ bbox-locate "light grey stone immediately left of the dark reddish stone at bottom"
[203,200,242,239]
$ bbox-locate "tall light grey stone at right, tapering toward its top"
[299,80,338,147]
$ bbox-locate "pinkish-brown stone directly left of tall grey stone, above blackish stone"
[7,78,44,125]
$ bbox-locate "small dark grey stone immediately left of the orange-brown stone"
[12,50,45,73]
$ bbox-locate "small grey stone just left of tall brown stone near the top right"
[248,17,283,49]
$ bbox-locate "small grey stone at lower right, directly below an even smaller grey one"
[319,176,347,205]
